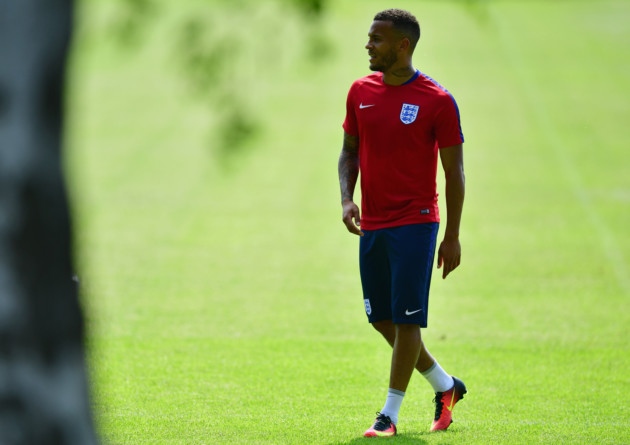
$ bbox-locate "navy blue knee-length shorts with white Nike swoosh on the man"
[359,223,439,327]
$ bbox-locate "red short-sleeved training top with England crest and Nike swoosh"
[343,71,464,230]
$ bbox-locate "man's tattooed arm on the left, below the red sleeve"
[337,132,363,236]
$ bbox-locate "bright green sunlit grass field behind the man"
[66,0,630,445]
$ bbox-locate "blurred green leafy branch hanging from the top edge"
[107,0,331,166]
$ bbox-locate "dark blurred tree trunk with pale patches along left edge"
[0,0,97,445]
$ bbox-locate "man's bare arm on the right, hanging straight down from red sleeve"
[438,144,466,278]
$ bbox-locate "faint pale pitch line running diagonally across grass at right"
[491,6,630,295]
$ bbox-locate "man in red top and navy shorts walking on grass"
[338,9,466,437]
